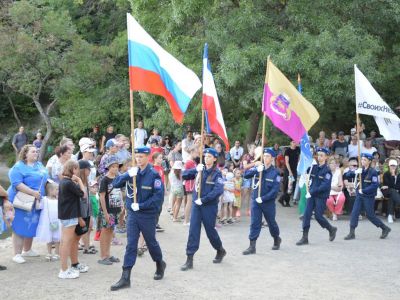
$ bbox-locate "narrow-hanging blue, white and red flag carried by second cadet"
[203,44,229,150]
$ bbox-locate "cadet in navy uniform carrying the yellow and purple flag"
[243,148,282,255]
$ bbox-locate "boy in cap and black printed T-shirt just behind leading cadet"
[98,156,123,265]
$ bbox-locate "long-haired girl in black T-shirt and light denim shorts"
[58,160,89,279]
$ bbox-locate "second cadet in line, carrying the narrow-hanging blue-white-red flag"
[181,148,226,271]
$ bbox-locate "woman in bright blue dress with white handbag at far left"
[8,145,48,264]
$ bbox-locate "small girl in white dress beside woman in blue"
[36,180,61,261]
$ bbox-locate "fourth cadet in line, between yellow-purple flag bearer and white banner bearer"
[296,148,337,246]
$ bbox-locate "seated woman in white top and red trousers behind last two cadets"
[326,158,346,221]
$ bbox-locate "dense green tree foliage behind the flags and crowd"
[0,0,400,155]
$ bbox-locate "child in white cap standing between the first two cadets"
[169,160,183,222]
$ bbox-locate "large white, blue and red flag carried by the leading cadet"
[127,13,201,123]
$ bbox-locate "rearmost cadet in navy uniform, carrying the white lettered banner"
[344,153,391,240]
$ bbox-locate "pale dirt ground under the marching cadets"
[0,199,400,300]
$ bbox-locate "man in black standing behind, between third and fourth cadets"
[278,141,300,207]
